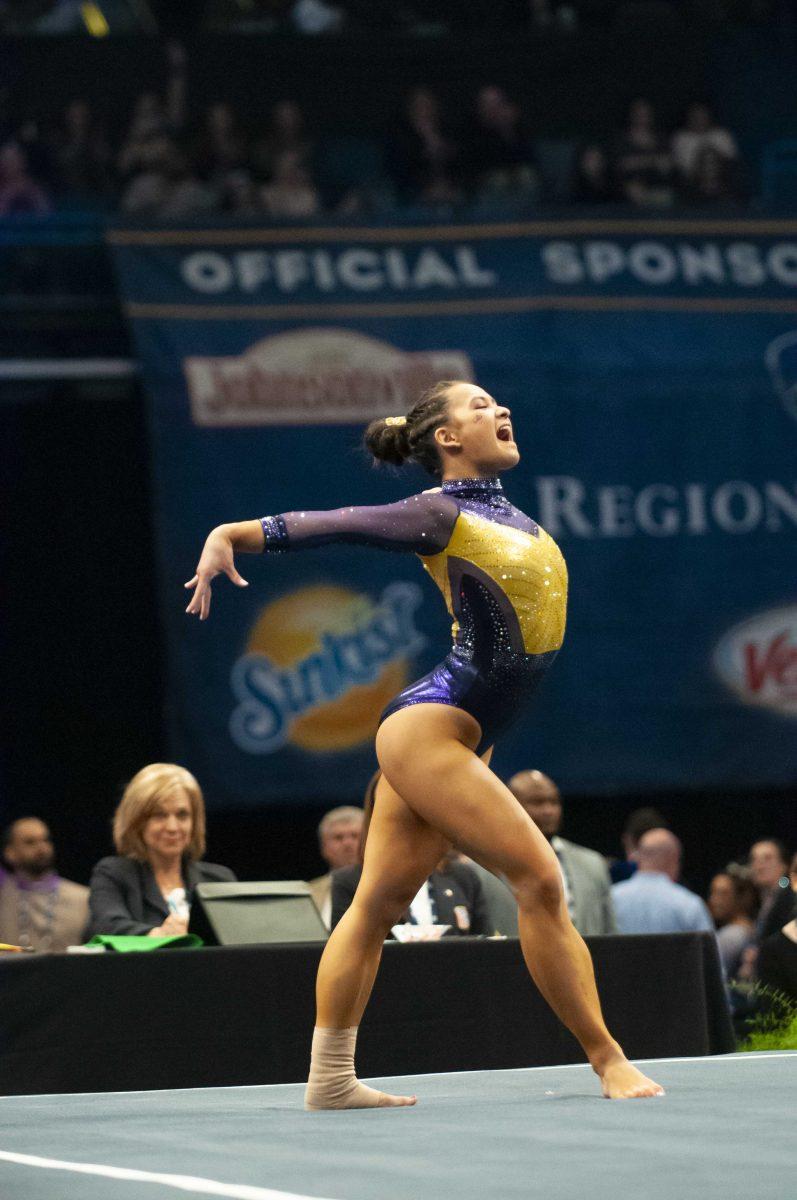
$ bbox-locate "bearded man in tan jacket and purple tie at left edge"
[0,817,89,953]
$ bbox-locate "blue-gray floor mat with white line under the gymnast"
[0,1052,797,1200]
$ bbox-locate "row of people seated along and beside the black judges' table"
[0,763,797,1022]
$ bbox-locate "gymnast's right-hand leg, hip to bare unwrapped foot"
[377,704,664,1099]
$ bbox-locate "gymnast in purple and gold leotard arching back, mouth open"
[186,382,664,1110]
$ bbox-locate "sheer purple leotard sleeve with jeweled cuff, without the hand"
[260,491,460,554]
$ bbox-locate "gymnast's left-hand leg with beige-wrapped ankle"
[305,776,448,1109]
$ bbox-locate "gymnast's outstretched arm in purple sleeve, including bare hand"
[186,491,459,620]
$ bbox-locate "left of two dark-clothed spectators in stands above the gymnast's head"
[389,88,462,204]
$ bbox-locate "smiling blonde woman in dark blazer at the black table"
[89,762,235,937]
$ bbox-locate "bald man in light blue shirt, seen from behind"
[612,829,714,934]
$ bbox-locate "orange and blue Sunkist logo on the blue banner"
[229,582,424,754]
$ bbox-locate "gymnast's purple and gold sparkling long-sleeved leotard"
[260,478,568,754]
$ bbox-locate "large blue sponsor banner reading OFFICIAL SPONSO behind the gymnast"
[110,221,797,806]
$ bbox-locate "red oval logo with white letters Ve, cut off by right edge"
[714,605,797,716]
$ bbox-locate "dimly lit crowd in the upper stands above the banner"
[0,43,745,221]
